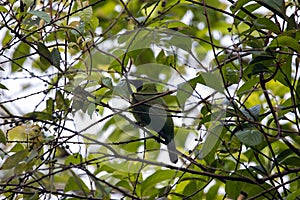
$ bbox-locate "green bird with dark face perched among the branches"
[130,80,178,163]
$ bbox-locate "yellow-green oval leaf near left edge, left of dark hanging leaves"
[11,42,30,72]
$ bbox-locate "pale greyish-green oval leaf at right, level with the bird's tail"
[235,129,264,146]
